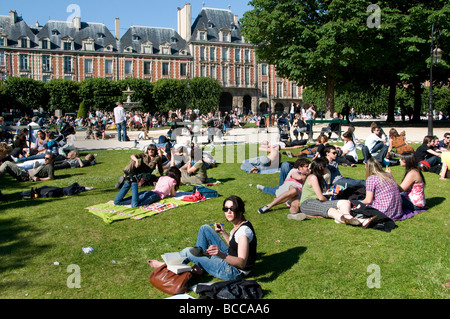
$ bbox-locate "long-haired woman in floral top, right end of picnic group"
[386,152,426,211]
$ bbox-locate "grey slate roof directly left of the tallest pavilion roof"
[120,26,189,55]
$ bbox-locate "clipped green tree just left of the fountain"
[79,78,122,111]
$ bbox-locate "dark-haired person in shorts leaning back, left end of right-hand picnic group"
[257,158,311,220]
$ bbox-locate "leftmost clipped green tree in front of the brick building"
[4,77,49,110]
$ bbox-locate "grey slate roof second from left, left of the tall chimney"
[36,20,117,51]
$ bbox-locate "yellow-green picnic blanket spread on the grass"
[86,192,208,224]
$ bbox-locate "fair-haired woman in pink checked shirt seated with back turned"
[361,158,403,221]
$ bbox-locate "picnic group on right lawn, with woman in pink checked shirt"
[257,145,426,228]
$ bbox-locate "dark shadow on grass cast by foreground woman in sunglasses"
[251,247,306,282]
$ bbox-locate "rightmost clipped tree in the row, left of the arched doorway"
[189,77,222,114]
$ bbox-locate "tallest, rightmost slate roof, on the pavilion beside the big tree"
[191,8,243,43]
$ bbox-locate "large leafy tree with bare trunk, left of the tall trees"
[241,0,368,117]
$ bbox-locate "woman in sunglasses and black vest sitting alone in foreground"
[148,196,257,281]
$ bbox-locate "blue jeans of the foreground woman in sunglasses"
[180,225,241,281]
